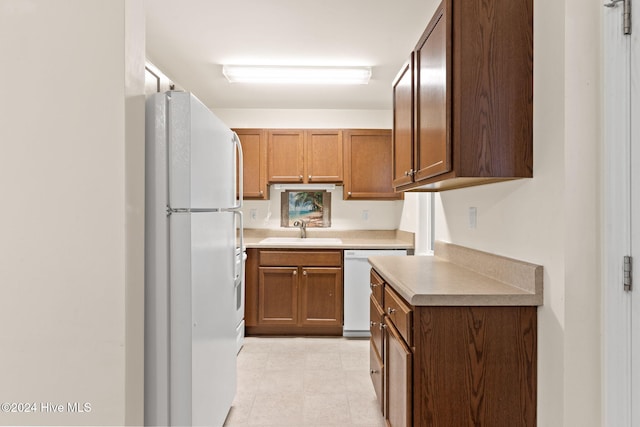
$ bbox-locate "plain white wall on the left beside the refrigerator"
[0,0,144,425]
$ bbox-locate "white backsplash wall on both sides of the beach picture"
[242,186,404,230]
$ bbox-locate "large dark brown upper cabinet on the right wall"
[392,0,533,191]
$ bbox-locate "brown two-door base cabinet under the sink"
[245,249,343,335]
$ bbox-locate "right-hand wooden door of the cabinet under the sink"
[300,267,343,326]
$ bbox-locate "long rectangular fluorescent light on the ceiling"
[222,65,371,84]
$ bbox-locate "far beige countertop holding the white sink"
[244,228,414,249]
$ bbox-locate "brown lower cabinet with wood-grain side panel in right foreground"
[371,270,537,427]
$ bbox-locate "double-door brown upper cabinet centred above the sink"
[267,129,343,184]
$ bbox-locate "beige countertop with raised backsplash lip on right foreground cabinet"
[369,242,543,306]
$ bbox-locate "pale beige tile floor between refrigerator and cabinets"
[225,337,384,427]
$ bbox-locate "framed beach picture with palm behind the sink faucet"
[280,190,331,227]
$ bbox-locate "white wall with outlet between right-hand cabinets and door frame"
[436,0,603,427]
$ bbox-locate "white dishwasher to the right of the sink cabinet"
[342,249,407,337]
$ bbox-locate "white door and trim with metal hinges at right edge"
[603,3,640,427]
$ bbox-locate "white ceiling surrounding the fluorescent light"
[145,0,439,109]
